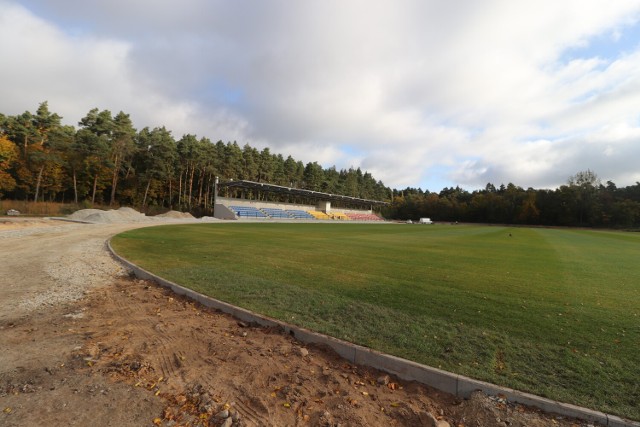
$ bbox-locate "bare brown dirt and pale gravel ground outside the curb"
[0,218,600,427]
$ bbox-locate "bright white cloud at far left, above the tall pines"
[0,2,246,137]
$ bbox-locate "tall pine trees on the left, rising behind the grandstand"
[0,102,391,213]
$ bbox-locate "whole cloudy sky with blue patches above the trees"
[0,0,640,192]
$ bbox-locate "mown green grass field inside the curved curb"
[112,223,640,420]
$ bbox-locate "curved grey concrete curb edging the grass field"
[107,239,640,427]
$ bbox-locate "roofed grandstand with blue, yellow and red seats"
[214,181,388,221]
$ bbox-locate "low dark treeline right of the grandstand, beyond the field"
[387,170,640,228]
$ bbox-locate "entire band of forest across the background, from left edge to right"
[0,101,640,229]
